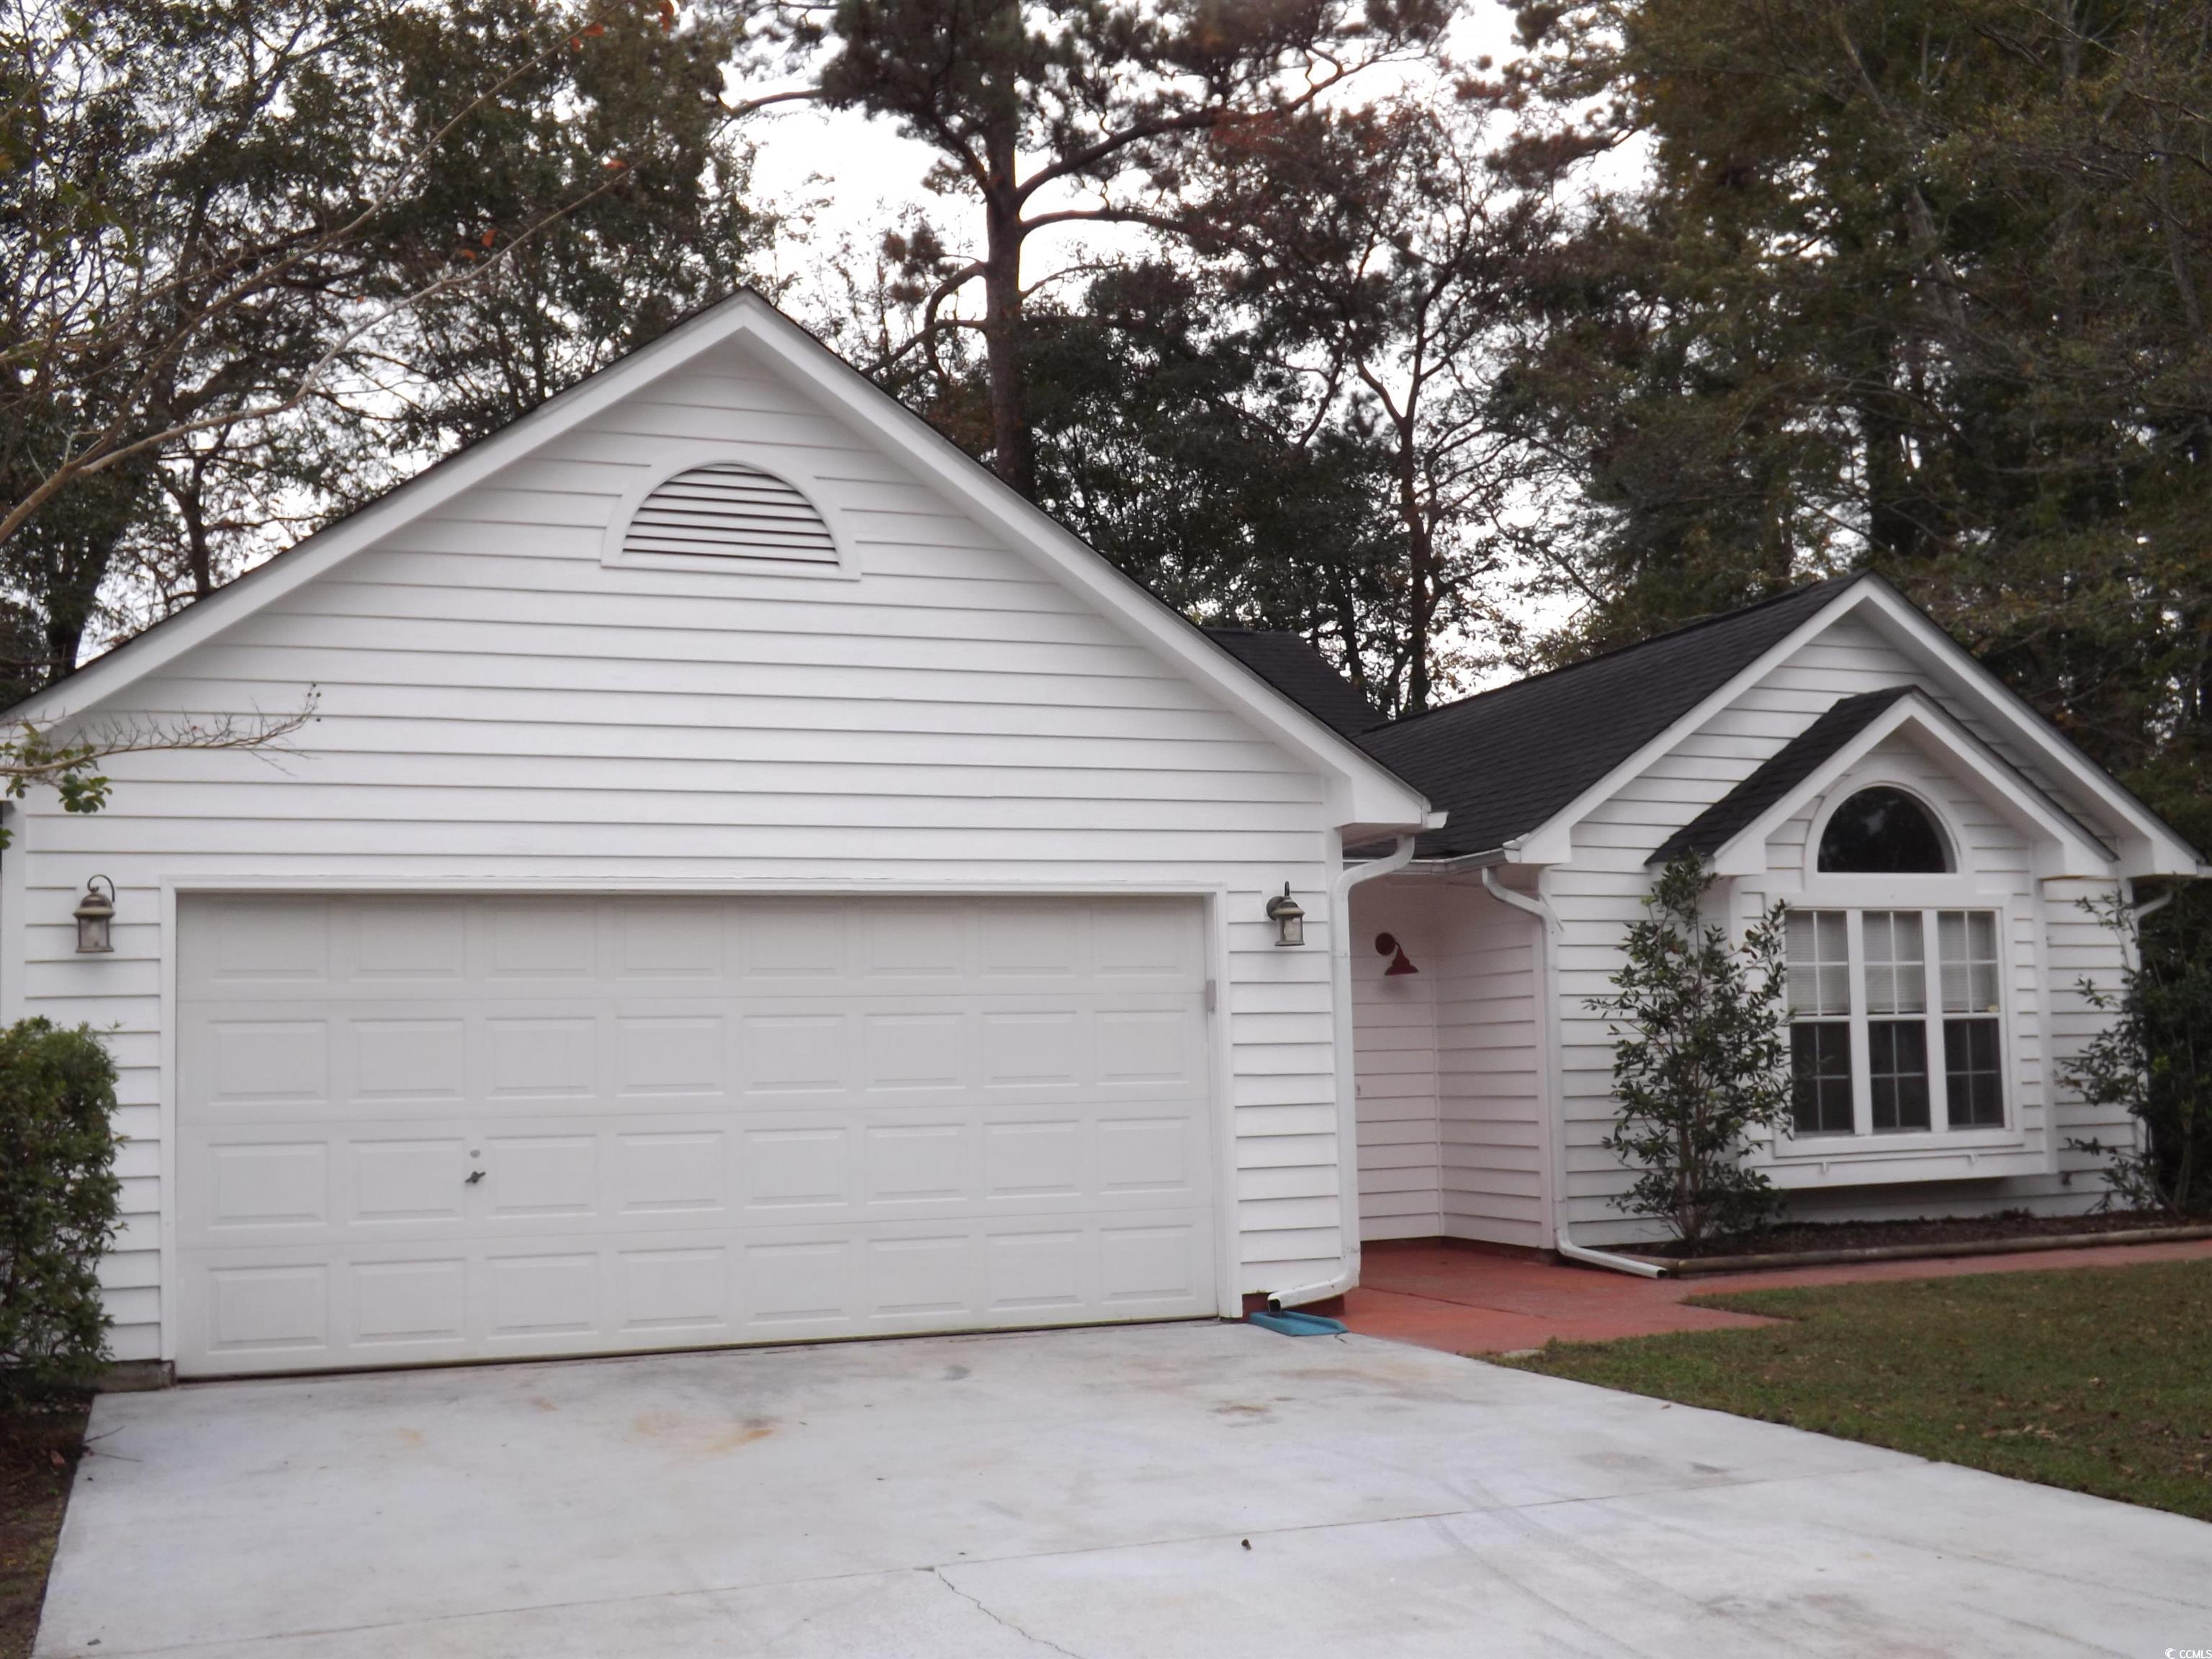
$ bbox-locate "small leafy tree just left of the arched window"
[1591,854,1789,1246]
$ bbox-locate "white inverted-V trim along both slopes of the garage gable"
[6,289,1438,830]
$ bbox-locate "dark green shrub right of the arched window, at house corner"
[2059,894,2212,1215]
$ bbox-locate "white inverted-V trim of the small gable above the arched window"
[1712,693,2117,881]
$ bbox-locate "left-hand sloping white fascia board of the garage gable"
[9,295,778,726]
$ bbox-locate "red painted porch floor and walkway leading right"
[1341,1238,2212,1354]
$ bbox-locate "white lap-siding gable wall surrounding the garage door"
[0,341,1339,1360]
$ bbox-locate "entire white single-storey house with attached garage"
[0,297,2203,1376]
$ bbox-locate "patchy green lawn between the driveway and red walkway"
[1509,1261,2212,1519]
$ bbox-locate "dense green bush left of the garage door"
[0,1020,122,1401]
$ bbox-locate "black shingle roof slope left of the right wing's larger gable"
[1358,577,1858,858]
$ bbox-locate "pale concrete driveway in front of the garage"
[37,1325,2212,1659]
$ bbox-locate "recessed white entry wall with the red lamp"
[1352,878,1546,1248]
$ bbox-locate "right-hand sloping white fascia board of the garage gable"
[750,303,1438,832]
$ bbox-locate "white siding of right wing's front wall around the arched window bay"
[1542,617,2121,1243]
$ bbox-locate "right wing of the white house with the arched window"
[1318,577,2208,1248]
